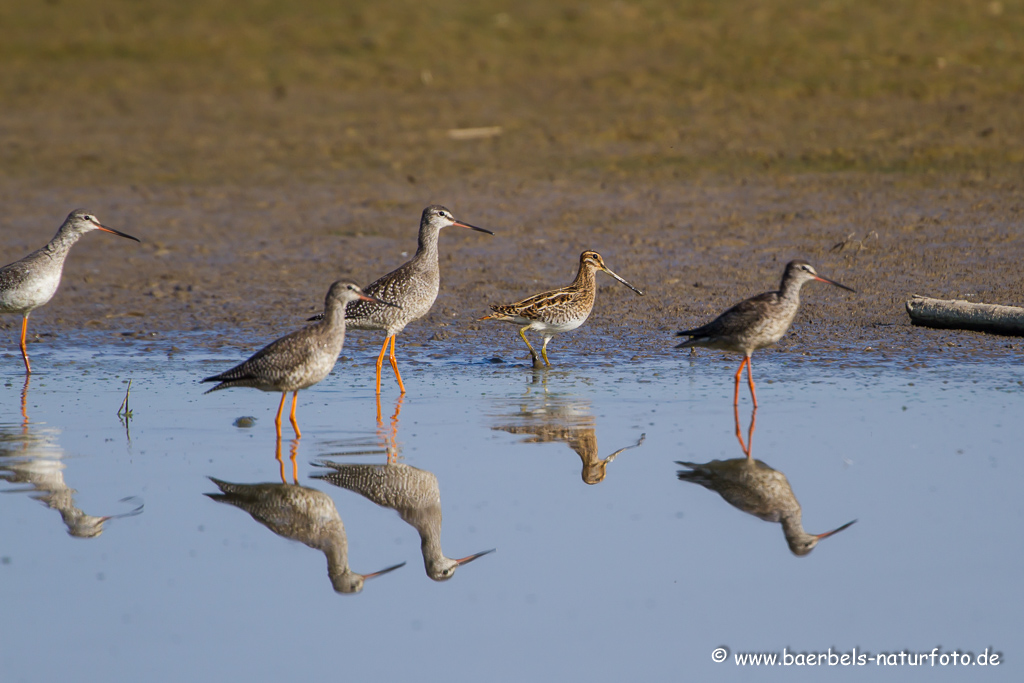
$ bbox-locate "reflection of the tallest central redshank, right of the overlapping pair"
[312,397,495,581]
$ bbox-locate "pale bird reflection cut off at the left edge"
[0,375,143,539]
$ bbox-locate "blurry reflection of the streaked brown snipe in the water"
[492,371,647,484]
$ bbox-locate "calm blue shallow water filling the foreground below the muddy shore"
[0,343,1024,681]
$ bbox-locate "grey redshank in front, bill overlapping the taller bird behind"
[203,281,396,438]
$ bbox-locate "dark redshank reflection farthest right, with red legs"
[676,408,857,556]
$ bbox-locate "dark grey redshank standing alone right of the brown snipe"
[676,260,854,408]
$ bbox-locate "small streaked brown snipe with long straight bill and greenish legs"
[479,250,643,368]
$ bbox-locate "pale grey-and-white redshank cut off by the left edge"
[0,209,139,373]
